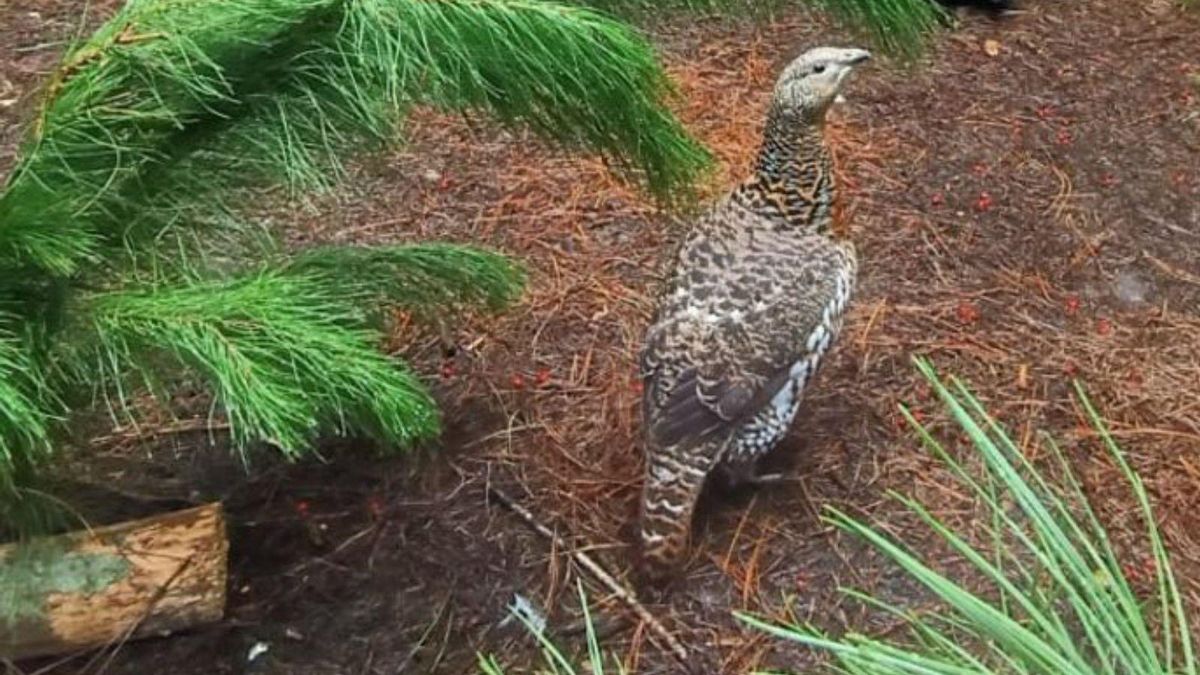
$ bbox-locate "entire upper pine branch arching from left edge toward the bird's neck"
[0,0,709,276]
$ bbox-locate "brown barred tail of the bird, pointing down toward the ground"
[640,450,713,579]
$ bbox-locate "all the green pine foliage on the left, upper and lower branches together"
[0,0,709,534]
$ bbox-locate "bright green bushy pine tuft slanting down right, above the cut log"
[66,265,438,456]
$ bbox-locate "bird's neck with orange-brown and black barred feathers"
[733,107,835,234]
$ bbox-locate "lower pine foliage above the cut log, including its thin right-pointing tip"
[0,239,524,534]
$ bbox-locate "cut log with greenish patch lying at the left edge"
[0,503,229,659]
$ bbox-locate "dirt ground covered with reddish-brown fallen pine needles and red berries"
[0,0,1200,675]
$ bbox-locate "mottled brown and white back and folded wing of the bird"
[642,237,853,447]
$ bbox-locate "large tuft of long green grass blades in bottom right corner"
[738,360,1196,675]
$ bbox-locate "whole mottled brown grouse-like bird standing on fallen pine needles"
[638,47,871,583]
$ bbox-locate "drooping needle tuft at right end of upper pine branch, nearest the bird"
[344,0,710,198]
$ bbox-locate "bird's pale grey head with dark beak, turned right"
[773,47,871,120]
